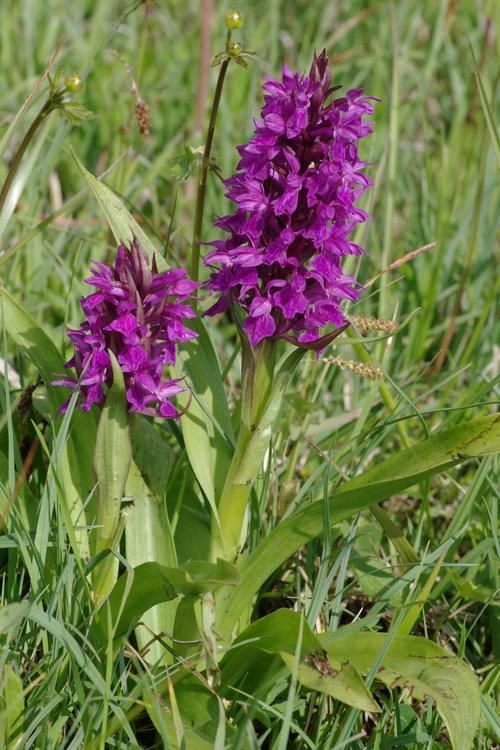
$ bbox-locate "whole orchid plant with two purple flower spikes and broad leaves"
[2,11,498,750]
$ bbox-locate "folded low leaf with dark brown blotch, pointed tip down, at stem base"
[221,609,379,711]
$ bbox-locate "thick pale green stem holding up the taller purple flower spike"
[212,339,279,561]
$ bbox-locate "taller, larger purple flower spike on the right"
[205,51,378,346]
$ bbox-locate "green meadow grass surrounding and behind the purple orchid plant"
[0,0,500,750]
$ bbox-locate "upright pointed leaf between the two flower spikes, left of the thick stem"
[175,320,234,508]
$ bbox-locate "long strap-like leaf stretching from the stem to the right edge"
[217,415,500,639]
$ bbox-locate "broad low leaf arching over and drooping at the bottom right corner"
[318,630,480,750]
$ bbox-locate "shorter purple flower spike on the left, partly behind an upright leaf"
[52,240,198,417]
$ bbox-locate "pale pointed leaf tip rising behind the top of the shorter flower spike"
[71,152,161,261]
